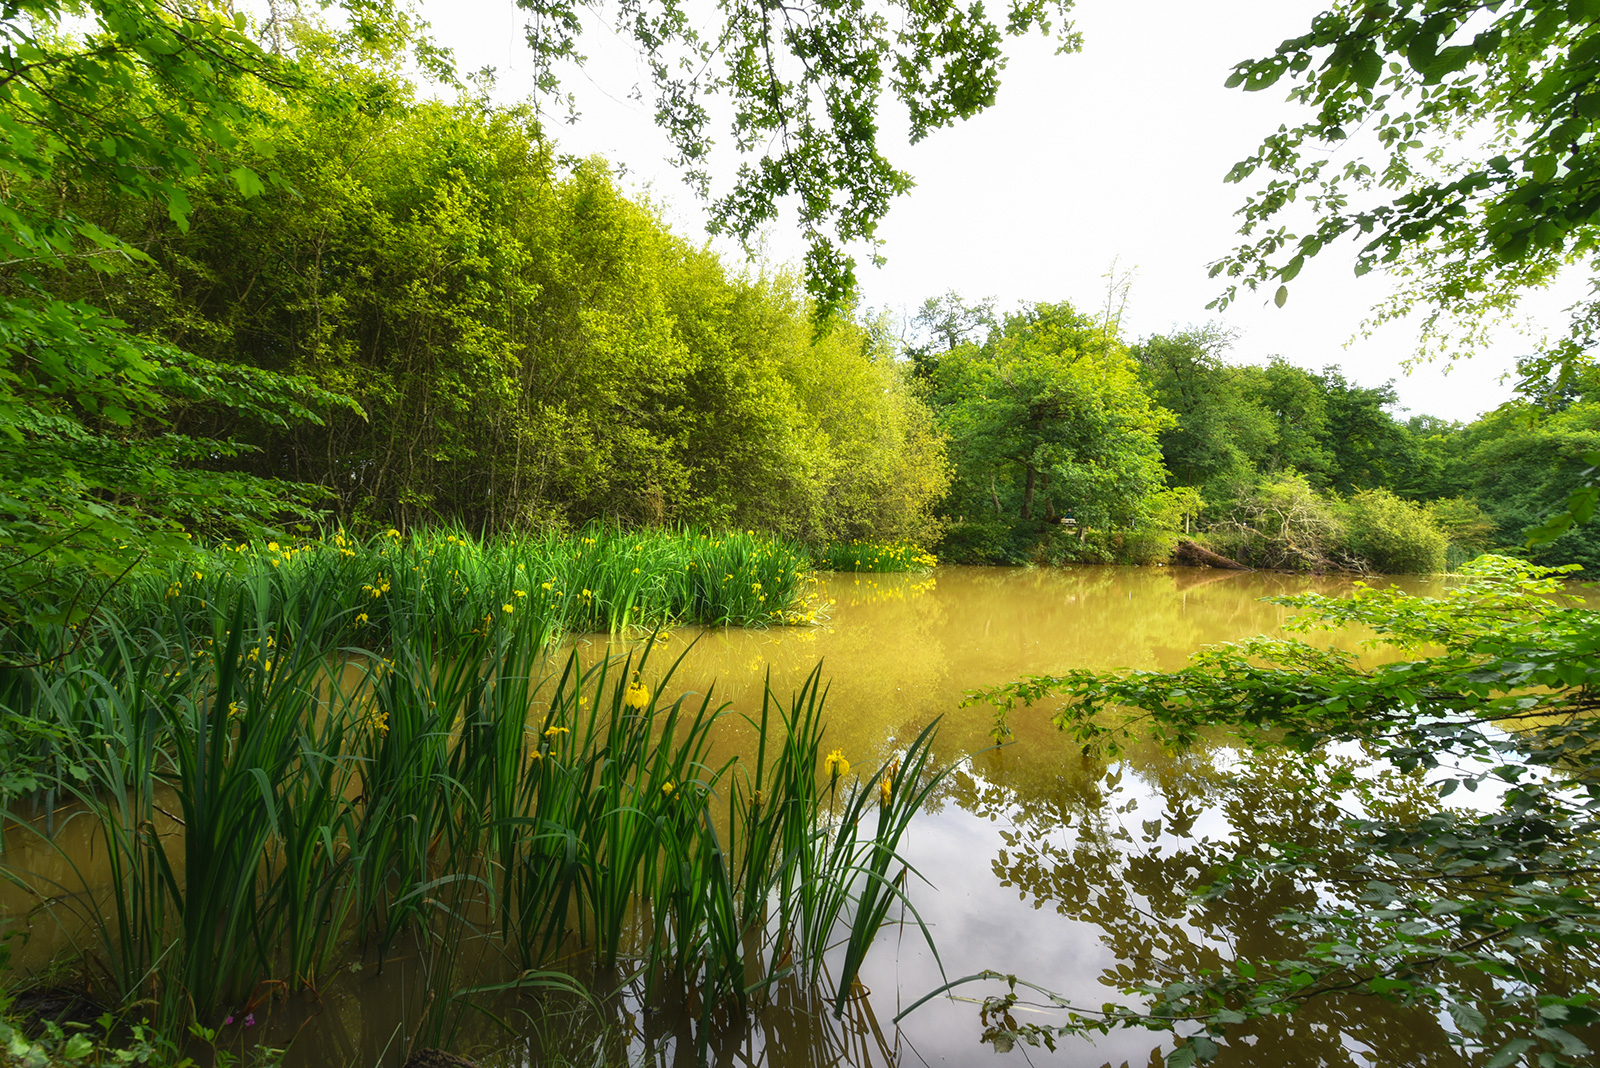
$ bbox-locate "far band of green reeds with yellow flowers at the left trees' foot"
[0,526,816,801]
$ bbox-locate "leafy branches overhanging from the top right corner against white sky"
[1211,0,1600,412]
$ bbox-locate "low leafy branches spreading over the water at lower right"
[974,558,1600,1066]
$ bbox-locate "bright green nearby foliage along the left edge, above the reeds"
[0,0,360,616]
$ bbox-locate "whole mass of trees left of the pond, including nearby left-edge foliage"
[0,0,960,626]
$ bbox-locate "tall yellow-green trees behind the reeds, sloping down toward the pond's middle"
[15,26,949,556]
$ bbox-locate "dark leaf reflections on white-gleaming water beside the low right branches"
[950,748,1491,1068]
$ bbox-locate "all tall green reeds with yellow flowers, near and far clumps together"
[0,562,938,1055]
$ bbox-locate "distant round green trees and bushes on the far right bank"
[907,294,1600,572]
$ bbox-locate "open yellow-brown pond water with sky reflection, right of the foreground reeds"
[611,568,1459,1066]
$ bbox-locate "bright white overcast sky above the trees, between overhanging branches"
[422,0,1570,420]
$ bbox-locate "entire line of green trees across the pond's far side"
[15,6,1600,585]
